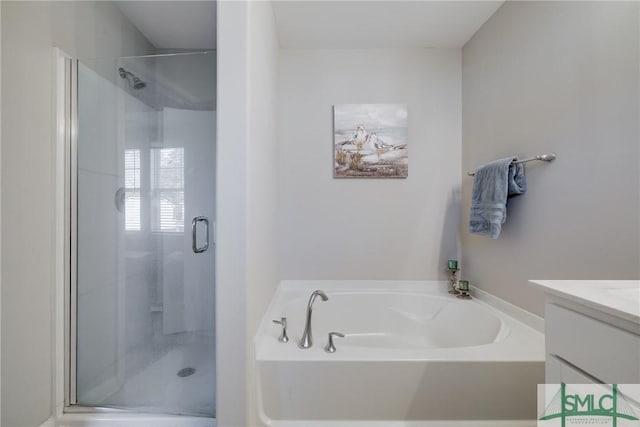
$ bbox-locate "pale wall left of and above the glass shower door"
[1,1,153,427]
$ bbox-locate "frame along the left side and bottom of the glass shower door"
[57,48,217,418]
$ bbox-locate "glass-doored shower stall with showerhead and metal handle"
[66,51,216,418]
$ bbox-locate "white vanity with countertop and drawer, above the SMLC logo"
[529,280,640,384]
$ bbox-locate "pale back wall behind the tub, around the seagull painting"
[278,49,461,279]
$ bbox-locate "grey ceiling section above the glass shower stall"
[114,0,216,49]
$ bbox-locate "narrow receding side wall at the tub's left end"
[247,2,280,425]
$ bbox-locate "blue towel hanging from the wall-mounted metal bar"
[469,157,527,239]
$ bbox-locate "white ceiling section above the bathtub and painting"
[273,0,504,49]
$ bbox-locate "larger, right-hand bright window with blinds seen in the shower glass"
[151,147,184,233]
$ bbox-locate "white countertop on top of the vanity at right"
[529,280,640,324]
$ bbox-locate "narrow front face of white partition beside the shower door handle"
[215,1,250,427]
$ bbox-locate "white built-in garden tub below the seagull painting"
[255,281,544,426]
